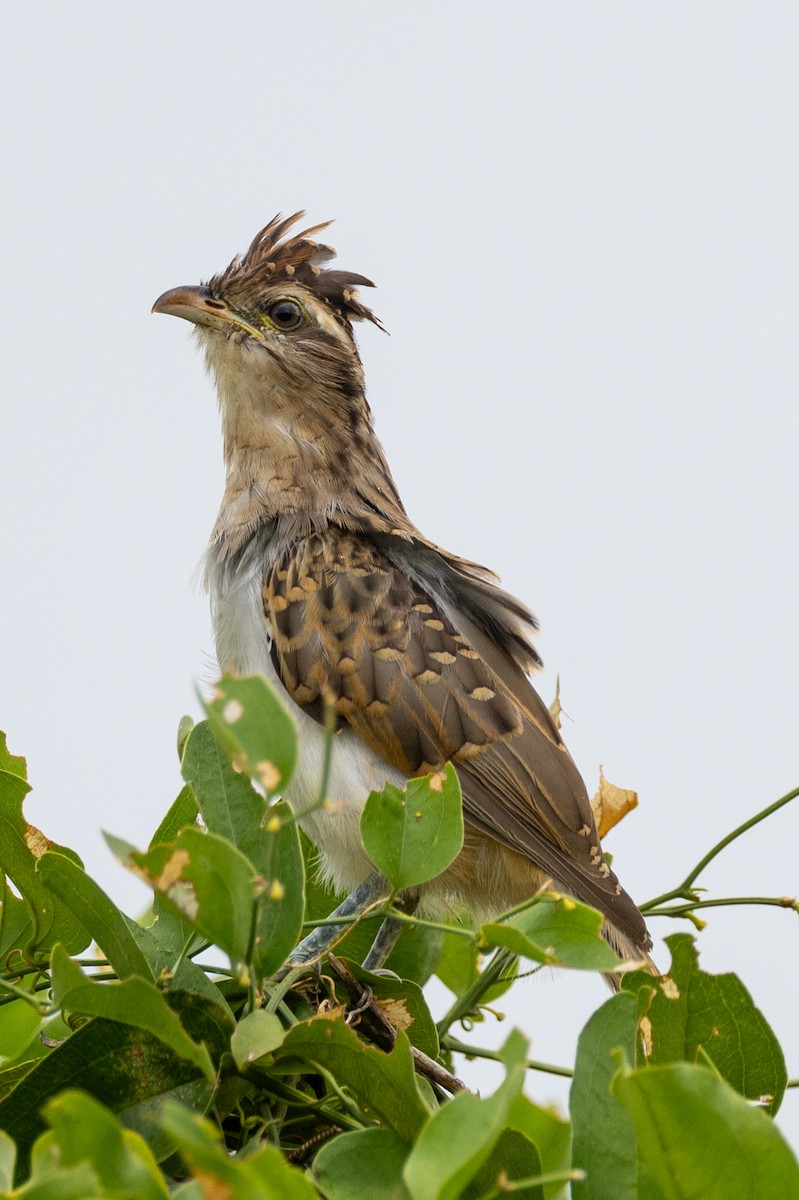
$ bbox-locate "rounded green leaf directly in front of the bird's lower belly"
[361,763,463,890]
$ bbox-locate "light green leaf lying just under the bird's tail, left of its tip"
[480,893,619,971]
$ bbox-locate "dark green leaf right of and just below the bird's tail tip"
[624,934,788,1114]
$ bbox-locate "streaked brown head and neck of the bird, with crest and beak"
[152,212,400,537]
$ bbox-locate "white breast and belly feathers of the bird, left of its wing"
[206,560,405,892]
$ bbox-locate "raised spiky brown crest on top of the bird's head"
[208,211,383,328]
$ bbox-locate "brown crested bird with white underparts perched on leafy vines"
[152,211,651,966]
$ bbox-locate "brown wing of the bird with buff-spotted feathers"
[264,527,647,946]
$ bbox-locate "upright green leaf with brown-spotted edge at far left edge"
[0,769,91,955]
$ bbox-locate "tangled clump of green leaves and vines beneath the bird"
[0,676,799,1200]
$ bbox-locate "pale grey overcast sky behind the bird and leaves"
[0,7,799,1145]
